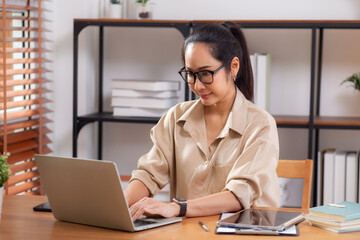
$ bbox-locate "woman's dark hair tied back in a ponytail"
[181,22,254,101]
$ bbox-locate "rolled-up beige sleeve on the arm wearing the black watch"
[224,115,280,208]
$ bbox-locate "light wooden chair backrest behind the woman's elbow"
[276,159,313,209]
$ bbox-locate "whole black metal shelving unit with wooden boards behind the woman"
[73,19,360,206]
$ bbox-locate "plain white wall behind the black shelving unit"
[53,0,360,174]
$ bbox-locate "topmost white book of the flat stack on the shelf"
[111,79,180,91]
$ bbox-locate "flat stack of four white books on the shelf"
[111,79,180,117]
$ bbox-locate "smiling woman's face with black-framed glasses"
[185,43,237,106]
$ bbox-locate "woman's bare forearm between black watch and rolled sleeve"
[186,191,242,217]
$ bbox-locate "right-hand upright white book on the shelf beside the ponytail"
[255,54,270,110]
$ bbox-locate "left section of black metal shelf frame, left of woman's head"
[72,19,191,159]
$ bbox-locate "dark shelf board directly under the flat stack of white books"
[78,112,160,124]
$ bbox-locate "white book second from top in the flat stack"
[111,88,178,98]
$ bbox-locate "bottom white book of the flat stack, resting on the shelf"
[113,107,167,117]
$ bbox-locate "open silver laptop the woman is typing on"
[35,155,182,232]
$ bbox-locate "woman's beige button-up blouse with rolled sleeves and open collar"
[130,90,280,208]
